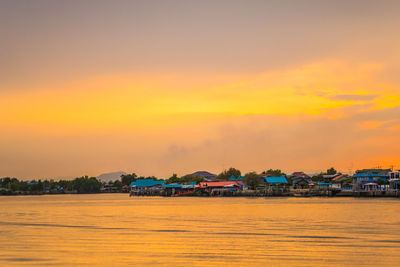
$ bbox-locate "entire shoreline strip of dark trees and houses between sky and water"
[0,168,400,197]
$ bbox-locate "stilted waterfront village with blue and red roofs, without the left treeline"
[130,168,400,197]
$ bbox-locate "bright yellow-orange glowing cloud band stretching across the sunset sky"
[0,59,400,128]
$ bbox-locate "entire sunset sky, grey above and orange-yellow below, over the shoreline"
[0,0,400,179]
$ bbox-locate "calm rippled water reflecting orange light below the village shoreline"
[0,194,400,266]
